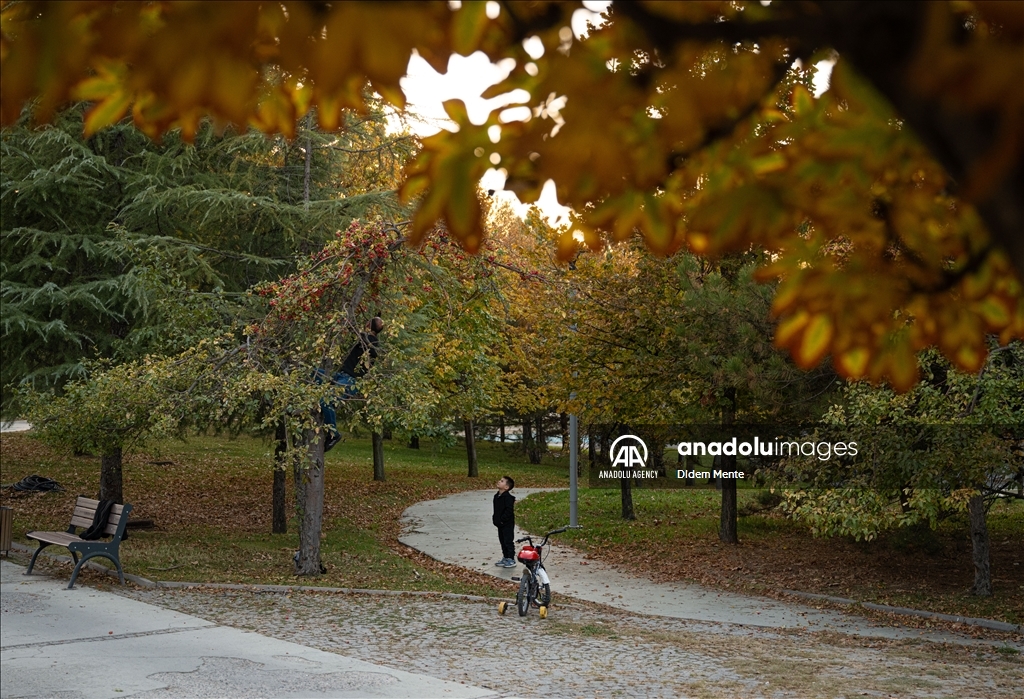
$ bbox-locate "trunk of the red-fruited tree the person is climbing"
[295,429,327,575]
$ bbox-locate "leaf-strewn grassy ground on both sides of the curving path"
[0,434,1024,634]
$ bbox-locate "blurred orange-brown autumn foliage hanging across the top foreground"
[0,1,1024,390]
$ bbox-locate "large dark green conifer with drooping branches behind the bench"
[0,105,412,411]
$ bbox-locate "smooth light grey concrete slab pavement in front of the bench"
[0,561,498,699]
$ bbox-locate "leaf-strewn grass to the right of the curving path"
[516,488,1024,624]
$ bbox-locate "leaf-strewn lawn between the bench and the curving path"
[0,434,568,595]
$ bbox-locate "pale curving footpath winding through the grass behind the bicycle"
[399,488,1024,650]
